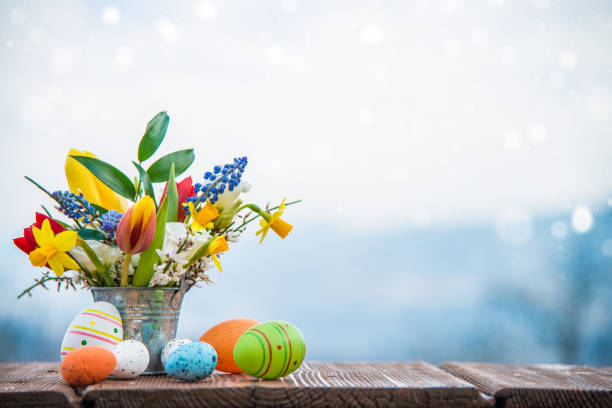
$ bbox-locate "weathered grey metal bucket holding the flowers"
[91,287,185,375]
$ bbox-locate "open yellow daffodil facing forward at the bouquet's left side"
[29,220,79,276]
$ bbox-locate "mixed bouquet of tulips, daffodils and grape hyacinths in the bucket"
[14,112,299,372]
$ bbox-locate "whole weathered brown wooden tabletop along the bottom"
[0,362,612,408]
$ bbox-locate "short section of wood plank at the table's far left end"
[0,363,78,408]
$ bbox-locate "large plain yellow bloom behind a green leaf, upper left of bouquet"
[66,149,127,213]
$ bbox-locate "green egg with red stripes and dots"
[234,320,306,379]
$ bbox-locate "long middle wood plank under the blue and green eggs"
[83,362,493,408]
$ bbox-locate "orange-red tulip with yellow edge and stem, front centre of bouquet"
[115,196,155,286]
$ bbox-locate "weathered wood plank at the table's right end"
[441,362,612,408]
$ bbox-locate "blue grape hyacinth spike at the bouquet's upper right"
[185,156,248,210]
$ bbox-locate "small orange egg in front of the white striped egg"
[60,346,117,387]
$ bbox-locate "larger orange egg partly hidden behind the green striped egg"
[200,319,259,373]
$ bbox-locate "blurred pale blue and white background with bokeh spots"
[0,0,612,365]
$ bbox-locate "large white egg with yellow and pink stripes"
[60,302,123,359]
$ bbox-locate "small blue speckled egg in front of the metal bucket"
[164,341,217,381]
